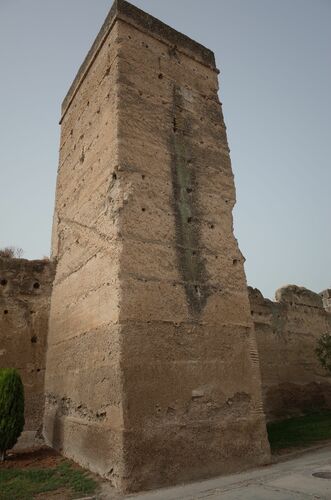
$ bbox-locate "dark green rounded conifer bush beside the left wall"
[0,368,24,462]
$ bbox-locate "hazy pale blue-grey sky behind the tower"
[0,0,331,298]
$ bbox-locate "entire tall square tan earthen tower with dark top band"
[44,0,269,491]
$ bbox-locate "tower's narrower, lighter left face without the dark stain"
[44,9,126,477]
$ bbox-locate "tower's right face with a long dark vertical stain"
[114,9,268,489]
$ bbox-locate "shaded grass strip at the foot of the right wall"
[267,410,331,451]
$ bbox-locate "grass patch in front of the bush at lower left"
[0,461,97,500]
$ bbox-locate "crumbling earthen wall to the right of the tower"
[249,285,331,420]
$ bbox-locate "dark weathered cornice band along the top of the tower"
[60,0,218,124]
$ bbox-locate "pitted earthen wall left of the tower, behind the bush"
[0,258,54,445]
